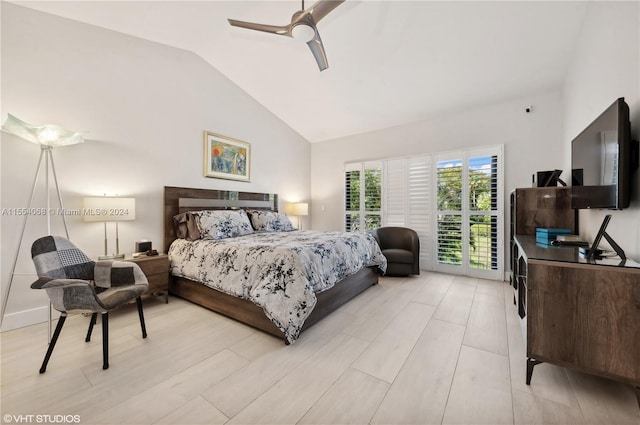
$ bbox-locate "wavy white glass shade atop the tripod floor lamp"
[2,114,84,147]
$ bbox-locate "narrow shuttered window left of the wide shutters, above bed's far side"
[344,162,382,233]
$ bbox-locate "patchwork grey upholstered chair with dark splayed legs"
[31,236,149,373]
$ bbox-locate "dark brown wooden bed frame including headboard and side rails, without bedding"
[163,186,378,343]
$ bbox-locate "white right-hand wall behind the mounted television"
[563,1,640,261]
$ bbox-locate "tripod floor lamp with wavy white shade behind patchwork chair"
[0,114,84,341]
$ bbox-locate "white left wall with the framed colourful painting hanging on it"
[0,2,310,329]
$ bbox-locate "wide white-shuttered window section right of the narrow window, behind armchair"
[382,146,503,279]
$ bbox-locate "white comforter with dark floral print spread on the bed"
[169,230,387,342]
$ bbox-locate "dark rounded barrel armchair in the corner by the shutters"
[372,227,420,276]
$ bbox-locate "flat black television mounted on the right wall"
[571,97,638,209]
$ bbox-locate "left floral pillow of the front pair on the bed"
[193,210,253,239]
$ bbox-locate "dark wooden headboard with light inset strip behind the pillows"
[162,186,278,252]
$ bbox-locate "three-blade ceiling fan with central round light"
[228,0,344,71]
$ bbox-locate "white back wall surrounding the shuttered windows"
[311,92,565,235]
